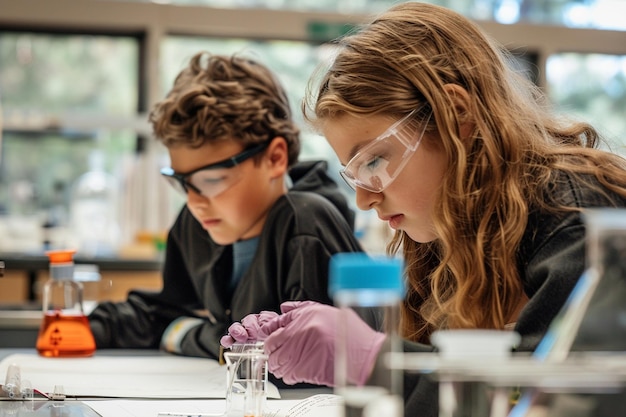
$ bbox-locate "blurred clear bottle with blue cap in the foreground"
[329,253,405,417]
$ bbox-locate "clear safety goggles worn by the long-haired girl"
[339,108,432,193]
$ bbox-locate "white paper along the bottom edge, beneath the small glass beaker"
[83,394,343,417]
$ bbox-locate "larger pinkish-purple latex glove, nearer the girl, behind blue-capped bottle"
[261,301,385,386]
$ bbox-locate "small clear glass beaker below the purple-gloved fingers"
[224,343,267,417]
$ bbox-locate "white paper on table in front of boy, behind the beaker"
[0,354,280,399]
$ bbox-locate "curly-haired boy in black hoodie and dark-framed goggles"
[89,53,361,358]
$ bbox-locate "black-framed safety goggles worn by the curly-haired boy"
[161,141,270,198]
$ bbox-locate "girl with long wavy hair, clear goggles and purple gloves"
[223,2,626,416]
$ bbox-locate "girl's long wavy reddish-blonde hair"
[303,2,626,342]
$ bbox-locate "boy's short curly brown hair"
[149,52,300,166]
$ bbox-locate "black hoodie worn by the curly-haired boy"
[89,161,362,358]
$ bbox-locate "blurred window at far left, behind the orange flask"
[0,31,139,250]
